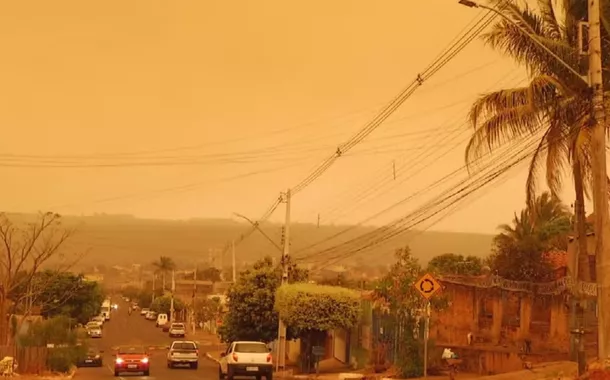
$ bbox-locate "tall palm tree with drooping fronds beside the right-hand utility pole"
[466,0,610,281]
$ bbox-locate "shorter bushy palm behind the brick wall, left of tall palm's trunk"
[490,192,571,281]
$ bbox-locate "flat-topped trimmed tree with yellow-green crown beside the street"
[275,283,362,368]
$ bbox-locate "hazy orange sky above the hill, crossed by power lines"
[0,0,571,232]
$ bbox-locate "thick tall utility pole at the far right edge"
[587,0,610,360]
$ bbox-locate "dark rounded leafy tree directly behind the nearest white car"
[219,257,308,342]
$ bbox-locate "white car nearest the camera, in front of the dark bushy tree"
[218,341,273,380]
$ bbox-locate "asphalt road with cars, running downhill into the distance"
[75,303,218,380]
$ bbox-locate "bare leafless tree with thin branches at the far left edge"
[0,212,71,345]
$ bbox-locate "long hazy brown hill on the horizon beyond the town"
[2,214,493,267]
